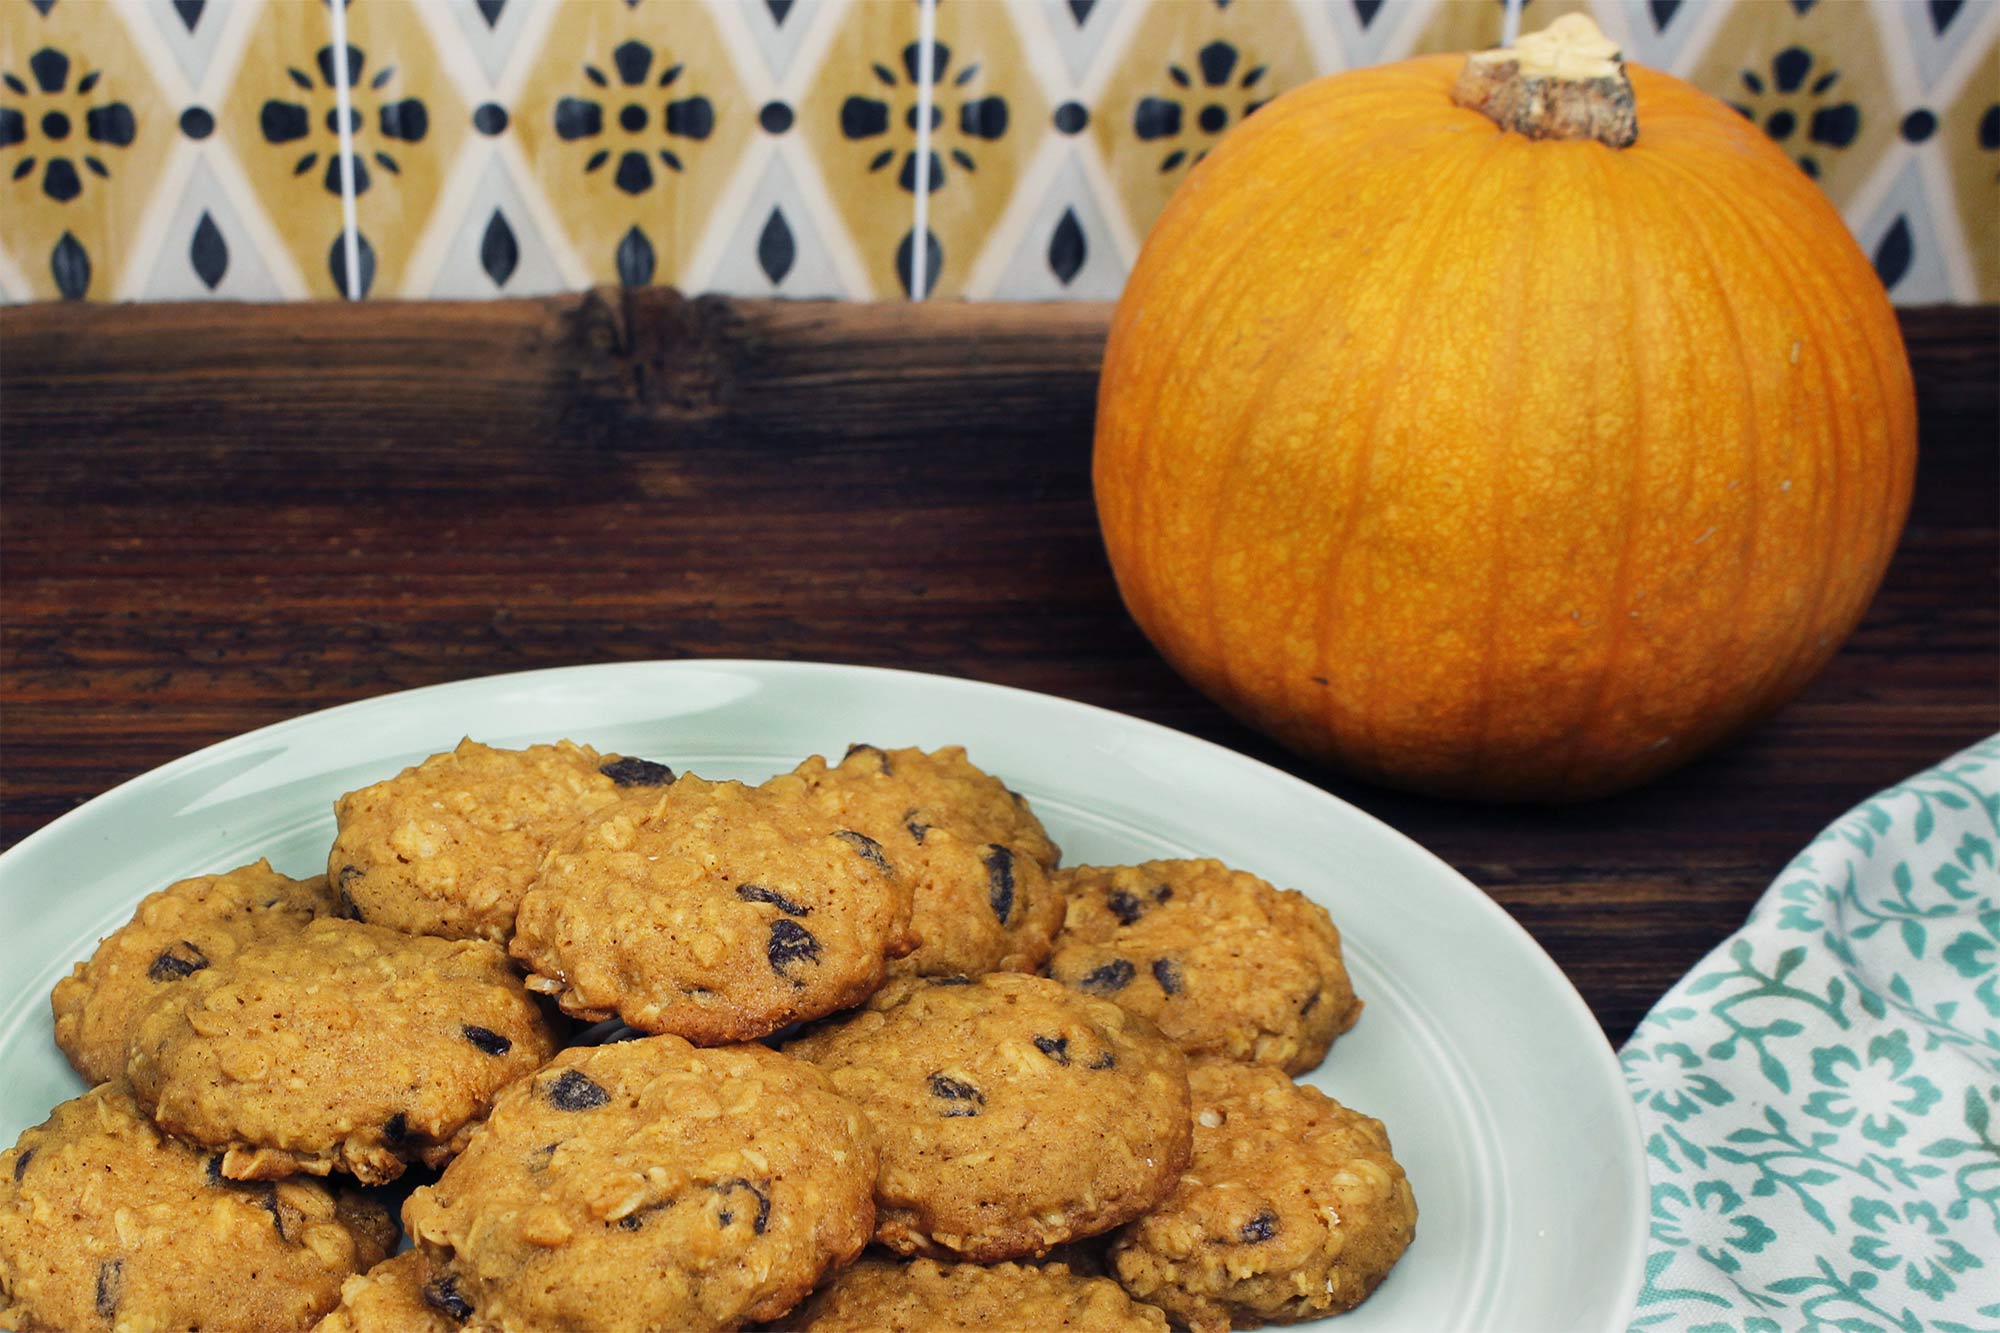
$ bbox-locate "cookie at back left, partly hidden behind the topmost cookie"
[326,741,674,945]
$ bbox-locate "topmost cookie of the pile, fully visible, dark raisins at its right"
[512,775,916,1045]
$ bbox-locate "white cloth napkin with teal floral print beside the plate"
[1620,737,2000,1333]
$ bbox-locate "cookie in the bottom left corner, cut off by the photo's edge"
[0,1083,396,1331]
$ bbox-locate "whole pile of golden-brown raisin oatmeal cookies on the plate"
[0,741,1416,1333]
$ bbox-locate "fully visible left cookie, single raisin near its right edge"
[128,917,558,1185]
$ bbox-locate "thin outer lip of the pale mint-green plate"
[0,656,1650,1333]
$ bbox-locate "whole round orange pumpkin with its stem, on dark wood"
[1092,16,1916,801]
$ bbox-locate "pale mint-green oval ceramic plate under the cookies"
[0,662,1646,1333]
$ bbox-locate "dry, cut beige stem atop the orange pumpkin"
[1452,14,1638,148]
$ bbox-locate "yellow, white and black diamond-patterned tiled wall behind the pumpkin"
[0,0,2000,304]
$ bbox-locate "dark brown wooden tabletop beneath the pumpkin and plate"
[0,290,2000,1043]
